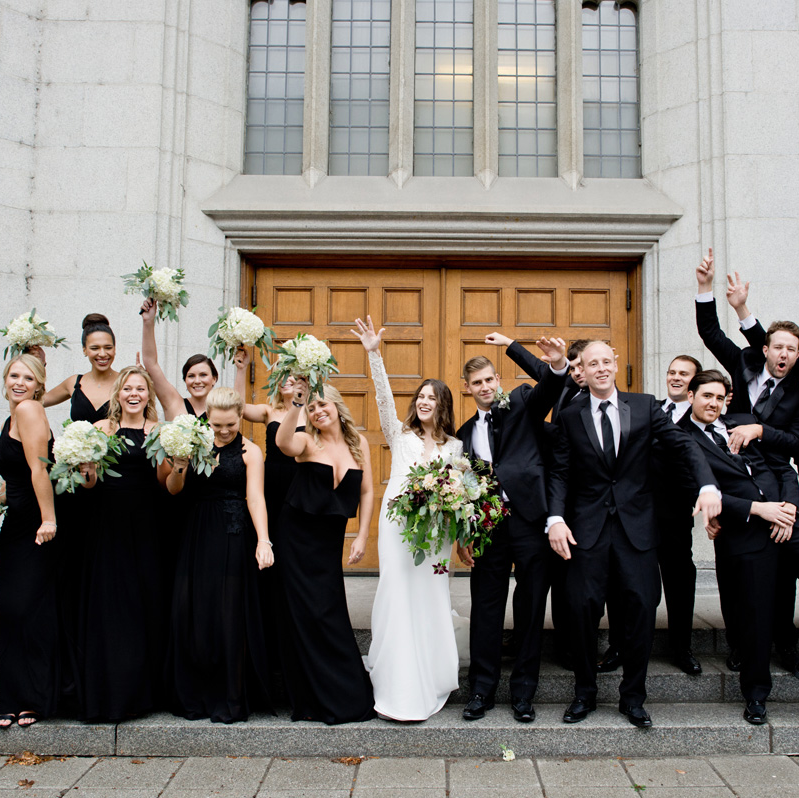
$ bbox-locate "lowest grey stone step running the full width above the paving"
[0,703,799,758]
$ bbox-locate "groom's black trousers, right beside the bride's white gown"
[469,512,550,699]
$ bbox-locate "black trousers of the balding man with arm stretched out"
[566,514,660,707]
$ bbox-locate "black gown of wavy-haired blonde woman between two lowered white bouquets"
[75,427,170,720]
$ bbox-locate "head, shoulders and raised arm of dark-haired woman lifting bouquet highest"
[141,299,219,421]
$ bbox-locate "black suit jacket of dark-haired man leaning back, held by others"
[679,413,799,557]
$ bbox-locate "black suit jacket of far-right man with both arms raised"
[696,300,799,459]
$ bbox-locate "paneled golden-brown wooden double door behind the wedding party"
[243,261,638,570]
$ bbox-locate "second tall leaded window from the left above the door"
[328,0,391,175]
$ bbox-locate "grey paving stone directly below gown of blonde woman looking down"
[164,757,269,798]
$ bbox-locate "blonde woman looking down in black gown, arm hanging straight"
[167,388,274,723]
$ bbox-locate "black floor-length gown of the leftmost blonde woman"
[0,418,59,717]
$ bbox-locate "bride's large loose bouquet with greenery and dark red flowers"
[388,457,510,573]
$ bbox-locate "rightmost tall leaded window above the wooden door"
[583,0,641,177]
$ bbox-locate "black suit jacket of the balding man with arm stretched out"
[549,391,716,551]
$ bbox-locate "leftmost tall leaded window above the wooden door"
[244,2,305,175]
